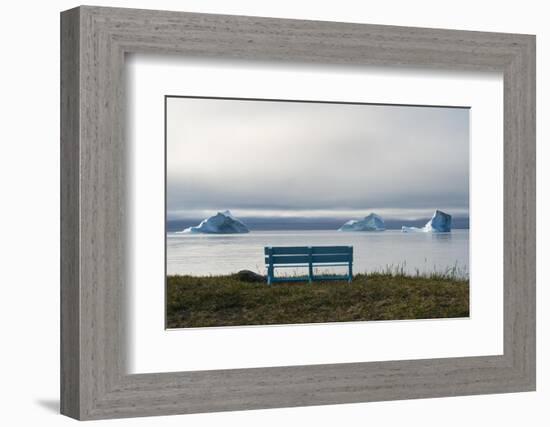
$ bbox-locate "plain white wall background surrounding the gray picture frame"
[0,0,550,427]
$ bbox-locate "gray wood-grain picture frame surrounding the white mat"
[61,6,535,419]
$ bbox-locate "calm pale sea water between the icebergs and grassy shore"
[166,230,469,276]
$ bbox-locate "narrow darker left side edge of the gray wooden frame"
[60,10,80,417]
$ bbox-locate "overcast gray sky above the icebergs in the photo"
[167,97,469,219]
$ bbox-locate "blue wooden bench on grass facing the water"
[264,246,353,285]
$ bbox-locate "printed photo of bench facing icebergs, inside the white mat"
[165,95,470,329]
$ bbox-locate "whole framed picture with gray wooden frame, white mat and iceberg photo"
[61,6,536,420]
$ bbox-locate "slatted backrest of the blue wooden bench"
[264,246,353,265]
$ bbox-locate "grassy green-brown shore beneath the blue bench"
[166,272,469,328]
